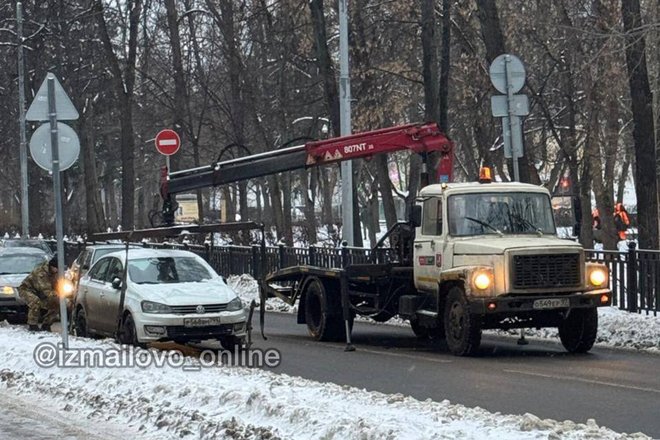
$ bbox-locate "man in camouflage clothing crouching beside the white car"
[18,256,59,331]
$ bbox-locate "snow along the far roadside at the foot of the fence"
[229,275,660,353]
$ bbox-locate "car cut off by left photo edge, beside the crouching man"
[0,247,51,323]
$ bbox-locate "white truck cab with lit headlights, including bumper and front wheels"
[410,181,611,355]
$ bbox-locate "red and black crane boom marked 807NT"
[161,123,453,223]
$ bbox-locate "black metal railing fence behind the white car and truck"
[51,242,660,316]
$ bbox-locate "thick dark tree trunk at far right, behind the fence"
[621,0,659,249]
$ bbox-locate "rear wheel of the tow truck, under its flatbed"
[305,278,345,341]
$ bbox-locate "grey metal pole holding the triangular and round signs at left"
[47,73,69,349]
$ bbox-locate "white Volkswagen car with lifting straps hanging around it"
[74,249,247,350]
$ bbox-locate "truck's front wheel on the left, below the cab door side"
[444,287,481,356]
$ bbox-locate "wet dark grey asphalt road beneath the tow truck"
[248,313,660,438]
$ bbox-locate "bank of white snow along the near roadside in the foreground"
[0,324,649,439]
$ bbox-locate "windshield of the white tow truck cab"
[447,192,556,236]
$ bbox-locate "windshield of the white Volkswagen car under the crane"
[128,257,212,284]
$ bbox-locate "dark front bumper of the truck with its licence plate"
[469,289,612,315]
